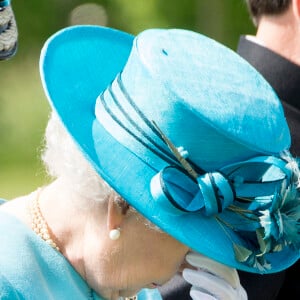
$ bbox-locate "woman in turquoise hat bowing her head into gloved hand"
[0,26,300,299]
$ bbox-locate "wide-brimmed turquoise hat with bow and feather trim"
[40,25,300,273]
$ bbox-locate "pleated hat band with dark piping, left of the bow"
[95,74,205,174]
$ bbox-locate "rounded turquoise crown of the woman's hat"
[96,29,290,170]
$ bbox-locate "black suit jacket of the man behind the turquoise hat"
[160,36,300,300]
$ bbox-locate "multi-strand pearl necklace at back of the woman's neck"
[30,189,60,251]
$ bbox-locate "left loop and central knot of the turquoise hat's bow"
[151,166,234,216]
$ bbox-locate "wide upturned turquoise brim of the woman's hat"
[40,25,297,273]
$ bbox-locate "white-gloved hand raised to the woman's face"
[182,252,248,300]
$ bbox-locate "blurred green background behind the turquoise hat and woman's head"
[0,0,255,199]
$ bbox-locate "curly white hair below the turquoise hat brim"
[41,112,112,200]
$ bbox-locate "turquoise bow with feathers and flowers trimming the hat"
[151,123,300,272]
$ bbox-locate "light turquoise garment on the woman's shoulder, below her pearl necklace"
[0,211,161,300]
